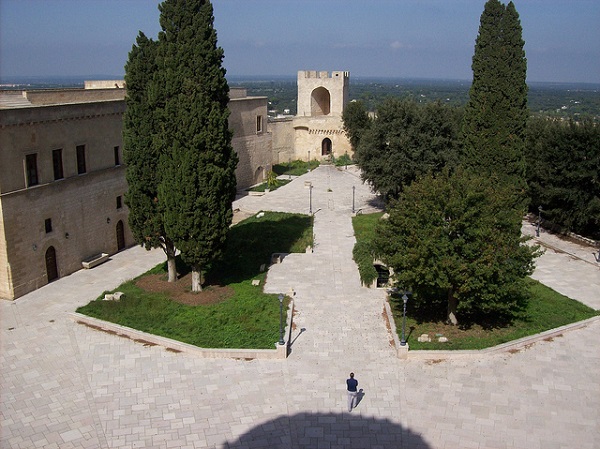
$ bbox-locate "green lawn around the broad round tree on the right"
[353,213,600,349]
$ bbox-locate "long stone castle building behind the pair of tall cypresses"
[0,80,272,299]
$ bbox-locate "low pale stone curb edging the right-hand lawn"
[384,301,600,359]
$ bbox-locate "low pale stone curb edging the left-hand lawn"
[69,300,294,360]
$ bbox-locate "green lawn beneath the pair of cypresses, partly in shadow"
[77,212,313,349]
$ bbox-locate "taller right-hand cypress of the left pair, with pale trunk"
[155,0,238,291]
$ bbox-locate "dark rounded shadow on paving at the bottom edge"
[222,413,431,449]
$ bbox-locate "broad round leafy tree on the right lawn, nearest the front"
[375,169,537,324]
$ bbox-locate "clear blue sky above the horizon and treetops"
[0,0,600,83]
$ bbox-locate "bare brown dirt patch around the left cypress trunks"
[136,273,234,306]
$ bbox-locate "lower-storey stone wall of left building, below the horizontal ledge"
[0,166,134,299]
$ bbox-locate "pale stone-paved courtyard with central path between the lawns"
[0,167,600,449]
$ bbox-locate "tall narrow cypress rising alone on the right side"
[463,0,529,189]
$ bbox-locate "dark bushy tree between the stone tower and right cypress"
[355,99,461,198]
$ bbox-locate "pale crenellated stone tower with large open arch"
[293,70,351,160]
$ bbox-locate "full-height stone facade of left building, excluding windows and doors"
[0,100,129,299]
